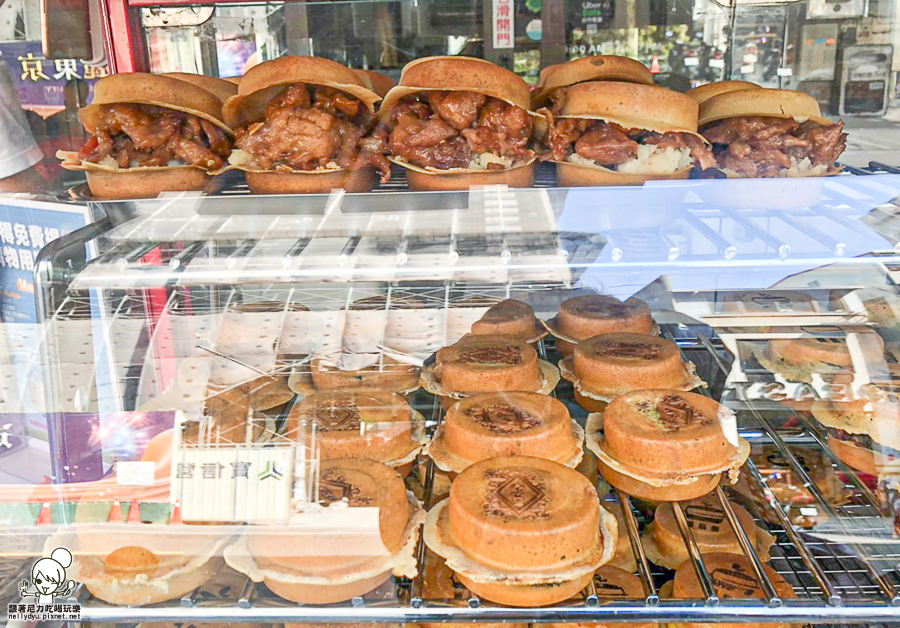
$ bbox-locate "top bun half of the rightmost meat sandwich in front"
[700,88,832,126]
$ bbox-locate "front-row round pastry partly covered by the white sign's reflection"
[232,458,422,604]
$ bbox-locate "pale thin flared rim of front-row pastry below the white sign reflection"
[223,491,425,586]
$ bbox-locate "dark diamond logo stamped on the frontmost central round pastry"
[484,469,551,521]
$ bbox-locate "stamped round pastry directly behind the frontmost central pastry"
[428,392,583,473]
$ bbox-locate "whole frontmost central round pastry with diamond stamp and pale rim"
[425,456,616,606]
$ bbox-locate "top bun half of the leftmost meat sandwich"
[78,72,231,133]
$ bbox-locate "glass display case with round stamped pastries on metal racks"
[0,168,900,625]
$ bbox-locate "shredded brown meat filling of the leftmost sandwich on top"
[78,104,231,170]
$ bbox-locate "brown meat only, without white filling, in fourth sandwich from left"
[541,118,716,170]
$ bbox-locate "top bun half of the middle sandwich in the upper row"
[379,57,531,115]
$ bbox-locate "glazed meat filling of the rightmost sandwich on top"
[702,116,847,177]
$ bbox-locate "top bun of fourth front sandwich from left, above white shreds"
[560,81,698,133]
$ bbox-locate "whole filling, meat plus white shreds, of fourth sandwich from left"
[541,118,716,173]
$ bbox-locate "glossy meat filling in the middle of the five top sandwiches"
[384,91,534,170]
